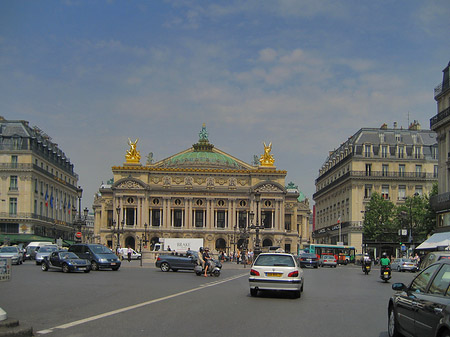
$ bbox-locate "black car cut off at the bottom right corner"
[388,259,450,337]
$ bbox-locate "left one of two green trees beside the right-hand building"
[363,192,397,242]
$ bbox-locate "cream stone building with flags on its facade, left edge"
[0,117,78,244]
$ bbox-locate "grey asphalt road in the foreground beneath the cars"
[0,261,415,337]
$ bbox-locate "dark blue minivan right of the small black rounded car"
[69,243,121,270]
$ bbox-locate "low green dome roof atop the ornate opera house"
[165,151,242,169]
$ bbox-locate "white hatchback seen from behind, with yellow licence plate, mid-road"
[249,253,304,298]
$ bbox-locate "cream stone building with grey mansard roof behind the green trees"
[312,121,438,253]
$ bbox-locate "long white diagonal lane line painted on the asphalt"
[36,273,248,335]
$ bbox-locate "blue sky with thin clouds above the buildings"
[0,0,450,209]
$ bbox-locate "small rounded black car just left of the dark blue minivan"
[41,250,91,273]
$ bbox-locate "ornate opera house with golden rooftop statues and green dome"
[93,125,310,253]
